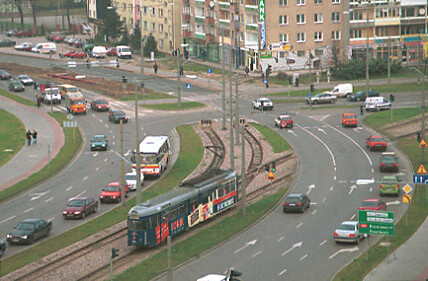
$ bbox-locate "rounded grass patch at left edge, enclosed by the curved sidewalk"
[0,109,26,167]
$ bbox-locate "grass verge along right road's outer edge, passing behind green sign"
[333,138,428,281]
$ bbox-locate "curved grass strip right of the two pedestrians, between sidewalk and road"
[0,112,82,202]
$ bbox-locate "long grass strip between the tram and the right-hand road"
[114,188,287,280]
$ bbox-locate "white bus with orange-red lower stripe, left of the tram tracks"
[131,136,171,177]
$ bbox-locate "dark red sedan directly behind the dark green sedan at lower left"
[62,197,98,219]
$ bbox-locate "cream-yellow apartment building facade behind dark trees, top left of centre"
[113,0,182,53]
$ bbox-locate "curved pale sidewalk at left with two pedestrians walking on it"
[0,96,64,190]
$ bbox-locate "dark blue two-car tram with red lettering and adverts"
[128,170,238,247]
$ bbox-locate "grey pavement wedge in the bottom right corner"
[364,217,428,281]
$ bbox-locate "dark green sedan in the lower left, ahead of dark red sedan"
[6,219,52,244]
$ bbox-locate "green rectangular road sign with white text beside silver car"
[358,210,394,235]
